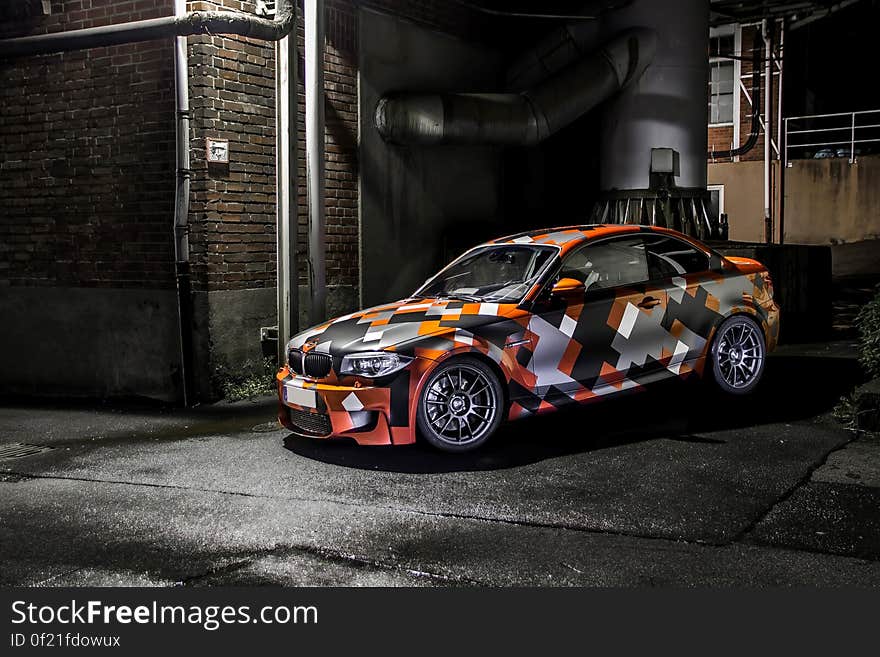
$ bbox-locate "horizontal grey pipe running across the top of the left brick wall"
[0,0,295,57]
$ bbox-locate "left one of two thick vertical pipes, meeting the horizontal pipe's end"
[275,21,299,364]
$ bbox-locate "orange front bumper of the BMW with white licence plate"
[276,367,415,445]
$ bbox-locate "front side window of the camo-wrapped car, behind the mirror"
[559,235,649,290]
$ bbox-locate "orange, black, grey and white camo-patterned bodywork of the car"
[277,226,779,444]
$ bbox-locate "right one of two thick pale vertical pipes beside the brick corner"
[304,0,327,324]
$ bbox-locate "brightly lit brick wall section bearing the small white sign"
[188,0,275,290]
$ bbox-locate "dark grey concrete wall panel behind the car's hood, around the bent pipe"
[359,10,502,305]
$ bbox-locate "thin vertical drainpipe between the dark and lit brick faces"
[174,0,194,406]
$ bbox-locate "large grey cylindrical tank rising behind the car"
[600,0,709,191]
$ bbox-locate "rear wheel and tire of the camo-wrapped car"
[710,315,767,395]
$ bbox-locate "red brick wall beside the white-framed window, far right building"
[709,26,779,162]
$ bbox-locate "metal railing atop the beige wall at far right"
[784,109,880,166]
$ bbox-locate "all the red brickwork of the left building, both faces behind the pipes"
[0,0,484,290]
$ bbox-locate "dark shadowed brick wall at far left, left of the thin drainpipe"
[0,0,175,288]
